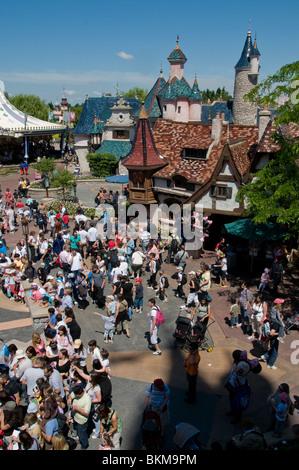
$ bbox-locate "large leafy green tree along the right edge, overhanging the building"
[237,62,299,238]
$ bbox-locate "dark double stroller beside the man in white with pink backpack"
[173,309,214,352]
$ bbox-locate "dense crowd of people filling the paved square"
[0,182,298,450]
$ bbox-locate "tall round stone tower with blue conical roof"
[233,29,260,126]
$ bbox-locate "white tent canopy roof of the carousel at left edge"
[0,82,66,137]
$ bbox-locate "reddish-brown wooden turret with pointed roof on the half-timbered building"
[122,105,168,210]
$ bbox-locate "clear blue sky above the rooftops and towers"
[0,0,299,104]
